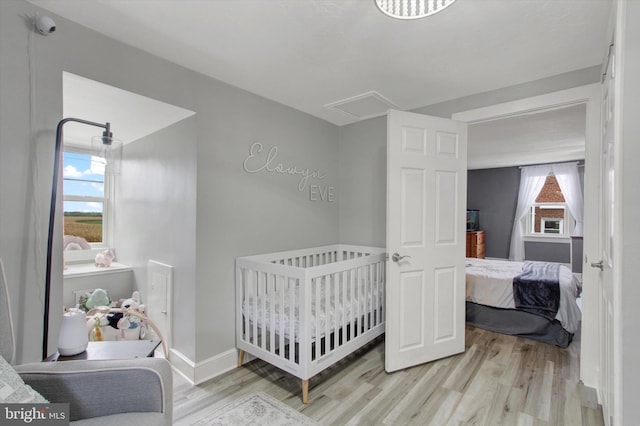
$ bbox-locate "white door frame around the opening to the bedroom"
[451,83,602,389]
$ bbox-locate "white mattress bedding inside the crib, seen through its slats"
[242,285,384,342]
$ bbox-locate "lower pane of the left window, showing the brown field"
[64,201,104,243]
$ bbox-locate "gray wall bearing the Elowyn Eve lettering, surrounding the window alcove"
[0,0,340,363]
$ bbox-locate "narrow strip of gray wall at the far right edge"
[614,1,640,424]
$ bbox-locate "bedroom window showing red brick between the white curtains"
[529,175,571,236]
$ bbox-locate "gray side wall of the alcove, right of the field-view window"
[114,116,197,353]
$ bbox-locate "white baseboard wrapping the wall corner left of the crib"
[169,348,252,385]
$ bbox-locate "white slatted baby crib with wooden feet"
[236,245,386,404]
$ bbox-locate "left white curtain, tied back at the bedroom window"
[509,164,551,262]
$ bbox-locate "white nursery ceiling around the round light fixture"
[29,0,611,125]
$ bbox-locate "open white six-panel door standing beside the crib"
[385,110,467,372]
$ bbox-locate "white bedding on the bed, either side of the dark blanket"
[465,258,581,333]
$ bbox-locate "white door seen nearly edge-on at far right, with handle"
[591,43,616,425]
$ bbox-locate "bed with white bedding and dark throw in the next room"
[465,258,581,348]
